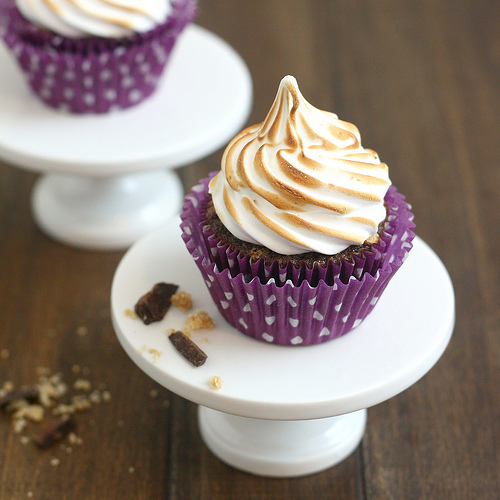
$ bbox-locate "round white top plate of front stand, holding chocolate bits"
[111,219,455,420]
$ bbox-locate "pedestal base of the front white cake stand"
[198,406,367,477]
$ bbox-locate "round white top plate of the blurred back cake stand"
[0,25,252,176]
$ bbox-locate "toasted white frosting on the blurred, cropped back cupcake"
[16,0,172,38]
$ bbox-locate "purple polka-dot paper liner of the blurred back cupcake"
[0,0,197,113]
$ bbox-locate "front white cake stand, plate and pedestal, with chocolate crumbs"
[111,220,455,477]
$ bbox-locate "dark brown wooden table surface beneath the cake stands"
[0,0,500,500]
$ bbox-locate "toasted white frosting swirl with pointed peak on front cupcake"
[210,76,391,255]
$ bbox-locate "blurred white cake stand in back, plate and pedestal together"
[0,25,252,250]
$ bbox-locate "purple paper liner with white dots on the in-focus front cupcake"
[181,175,415,345]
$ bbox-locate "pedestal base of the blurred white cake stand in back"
[31,170,184,250]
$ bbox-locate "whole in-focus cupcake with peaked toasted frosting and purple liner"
[181,76,414,345]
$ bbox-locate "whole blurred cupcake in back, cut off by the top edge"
[0,0,196,113]
